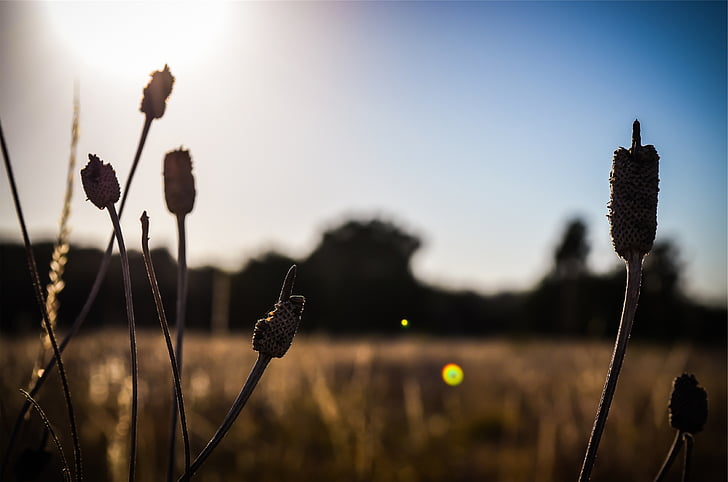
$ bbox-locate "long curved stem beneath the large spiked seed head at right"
[579,251,644,482]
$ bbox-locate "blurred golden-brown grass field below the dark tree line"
[0,332,727,481]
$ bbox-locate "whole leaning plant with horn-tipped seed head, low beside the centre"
[180,265,305,480]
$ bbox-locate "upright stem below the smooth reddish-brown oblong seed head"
[167,214,189,482]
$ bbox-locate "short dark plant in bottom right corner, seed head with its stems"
[655,373,708,482]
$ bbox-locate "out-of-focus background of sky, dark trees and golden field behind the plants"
[0,2,728,480]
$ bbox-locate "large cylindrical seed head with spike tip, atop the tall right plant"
[608,120,660,260]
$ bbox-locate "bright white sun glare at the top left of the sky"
[47,2,225,75]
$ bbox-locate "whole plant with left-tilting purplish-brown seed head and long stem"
[81,154,139,482]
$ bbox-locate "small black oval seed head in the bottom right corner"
[670,373,708,434]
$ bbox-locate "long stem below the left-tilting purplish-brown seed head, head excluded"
[106,204,139,482]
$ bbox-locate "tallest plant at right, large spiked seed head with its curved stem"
[579,120,660,481]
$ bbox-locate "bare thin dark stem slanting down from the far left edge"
[0,117,82,480]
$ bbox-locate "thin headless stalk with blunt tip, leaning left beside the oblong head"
[141,211,190,477]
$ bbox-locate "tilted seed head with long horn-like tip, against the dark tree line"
[253,265,305,358]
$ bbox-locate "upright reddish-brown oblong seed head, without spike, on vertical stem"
[164,148,195,216]
